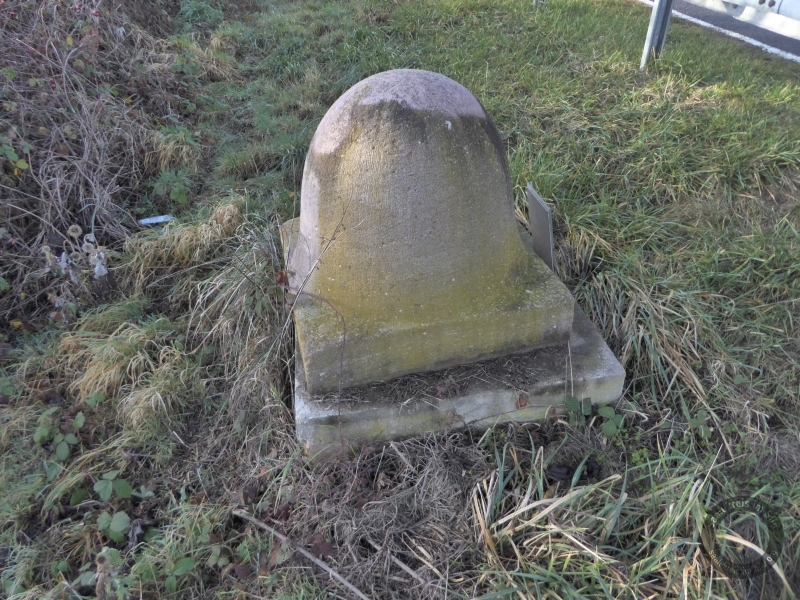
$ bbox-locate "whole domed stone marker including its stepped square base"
[281,69,624,455]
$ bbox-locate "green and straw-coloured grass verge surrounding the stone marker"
[0,0,800,599]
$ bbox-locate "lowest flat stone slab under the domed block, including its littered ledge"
[294,305,625,459]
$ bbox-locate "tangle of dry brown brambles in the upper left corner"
[0,0,219,321]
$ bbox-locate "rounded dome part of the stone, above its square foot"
[289,69,528,313]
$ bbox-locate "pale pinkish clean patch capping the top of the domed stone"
[310,69,487,153]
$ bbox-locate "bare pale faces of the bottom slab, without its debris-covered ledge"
[294,302,625,461]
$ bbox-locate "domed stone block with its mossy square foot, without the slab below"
[286,70,573,394]
